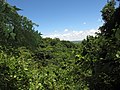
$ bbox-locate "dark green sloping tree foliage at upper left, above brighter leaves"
[0,1,41,49]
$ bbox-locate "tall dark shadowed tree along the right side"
[75,0,120,90]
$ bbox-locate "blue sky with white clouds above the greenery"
[7,0,107,41]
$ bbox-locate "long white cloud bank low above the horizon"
[43,29,98,41]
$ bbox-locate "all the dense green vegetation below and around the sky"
[0,0,120,90]
